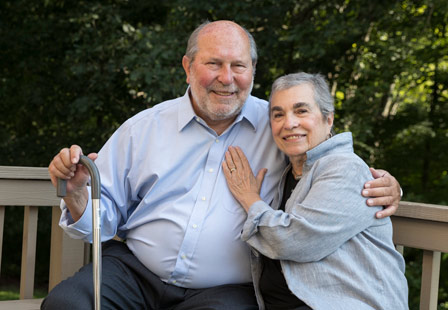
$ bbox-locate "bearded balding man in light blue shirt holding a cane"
[42,21,399,310]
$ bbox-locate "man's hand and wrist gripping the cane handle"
[48,145,98,221]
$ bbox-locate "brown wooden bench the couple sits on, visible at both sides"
[0,166,448,310]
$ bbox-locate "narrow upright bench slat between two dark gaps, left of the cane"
[20,206,38,299]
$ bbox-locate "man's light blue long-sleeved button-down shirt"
[60,91,285,288]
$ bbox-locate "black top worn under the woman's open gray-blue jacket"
[260,169,305,310]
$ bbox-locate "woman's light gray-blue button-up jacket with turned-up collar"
[241,132,408,310]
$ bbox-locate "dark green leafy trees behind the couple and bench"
[0,0,448,309]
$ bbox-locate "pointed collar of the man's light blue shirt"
[177,86,259,131]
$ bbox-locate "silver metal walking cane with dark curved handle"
[57,155,101,310]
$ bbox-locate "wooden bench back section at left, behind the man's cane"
[0,166,89,309]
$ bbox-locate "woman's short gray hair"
[269,72,334,119]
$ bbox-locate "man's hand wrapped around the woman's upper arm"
[362,168,401,218]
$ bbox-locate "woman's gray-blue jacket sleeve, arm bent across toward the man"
[241,157,389,262]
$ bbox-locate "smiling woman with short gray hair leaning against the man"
[223,73,408,310]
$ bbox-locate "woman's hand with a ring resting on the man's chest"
[222,146,267,212]
